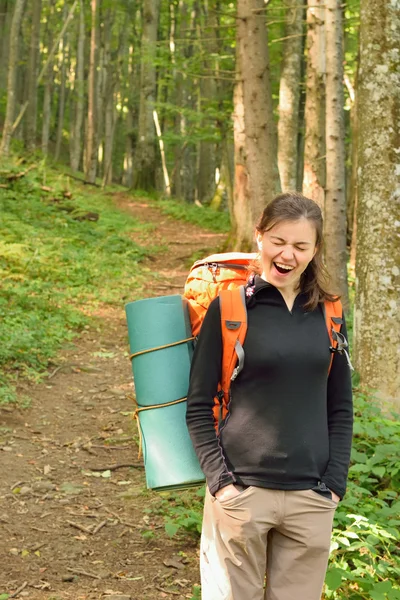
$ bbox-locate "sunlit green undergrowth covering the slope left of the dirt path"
[0,162,157,403]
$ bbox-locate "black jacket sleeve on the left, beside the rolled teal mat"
[186,298,235,495]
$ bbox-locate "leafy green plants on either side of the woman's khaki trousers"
[158,393,400,600]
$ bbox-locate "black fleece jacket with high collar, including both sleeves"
[186,277,353,497]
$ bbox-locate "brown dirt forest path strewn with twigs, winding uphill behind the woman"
[0,194,224,600]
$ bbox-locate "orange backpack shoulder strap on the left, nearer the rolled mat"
[219,285,247,401]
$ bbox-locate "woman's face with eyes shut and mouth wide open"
[256,218,317,291]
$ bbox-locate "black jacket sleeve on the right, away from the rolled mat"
[322,317,353,498]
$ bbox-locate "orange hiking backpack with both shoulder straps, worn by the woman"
[183,252,348,430]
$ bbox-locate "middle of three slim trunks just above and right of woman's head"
[303,0,326,209]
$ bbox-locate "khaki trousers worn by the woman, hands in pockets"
[200,486,336,600]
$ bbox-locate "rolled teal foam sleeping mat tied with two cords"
[125,295,204,491]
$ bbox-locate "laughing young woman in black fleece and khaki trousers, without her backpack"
[187,193,353,600]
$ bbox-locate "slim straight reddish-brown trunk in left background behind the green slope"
[85,0,99,183]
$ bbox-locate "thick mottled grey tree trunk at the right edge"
[354,0,400,411]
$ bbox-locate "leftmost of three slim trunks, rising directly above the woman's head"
[278,0,304,191]
